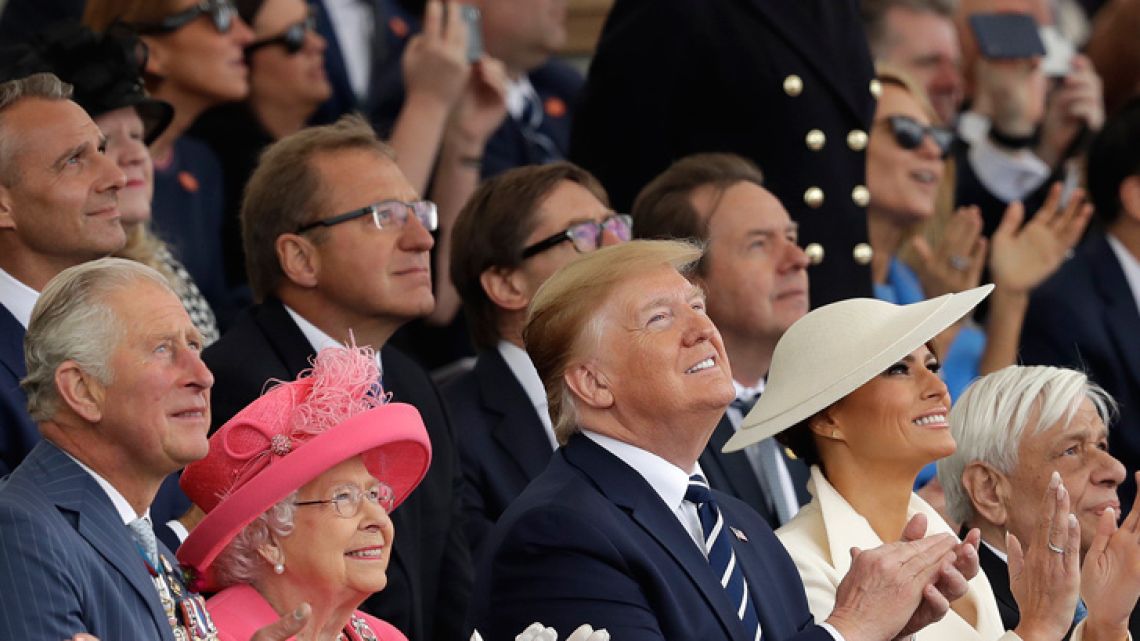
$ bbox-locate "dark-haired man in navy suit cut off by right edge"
[1021,98,1140,510]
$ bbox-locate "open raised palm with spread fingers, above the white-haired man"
[990,182,1092,294]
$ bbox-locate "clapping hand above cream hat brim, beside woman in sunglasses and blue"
[911,206,987,298]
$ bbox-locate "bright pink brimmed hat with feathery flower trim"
[178,348,431,591]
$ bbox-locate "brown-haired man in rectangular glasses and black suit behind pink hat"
[204,116,469,641]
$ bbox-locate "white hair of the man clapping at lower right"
[938,365,1116,524]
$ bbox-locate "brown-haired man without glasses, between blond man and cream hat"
[633,154,811,529]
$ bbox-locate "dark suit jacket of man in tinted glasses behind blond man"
[442,349,554,552]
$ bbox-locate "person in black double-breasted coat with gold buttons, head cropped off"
[570,0,879,305]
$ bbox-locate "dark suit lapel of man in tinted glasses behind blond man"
[475,349,552,479]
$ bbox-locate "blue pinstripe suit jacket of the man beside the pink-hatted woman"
[0,441,173,641]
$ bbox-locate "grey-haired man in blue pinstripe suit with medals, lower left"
[0,258,307,641]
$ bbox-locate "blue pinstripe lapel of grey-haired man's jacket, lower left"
[33,441,173,640]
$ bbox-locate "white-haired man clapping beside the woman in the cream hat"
[938,365,1140,639]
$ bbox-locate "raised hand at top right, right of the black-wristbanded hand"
[1036,54,1105,167]
